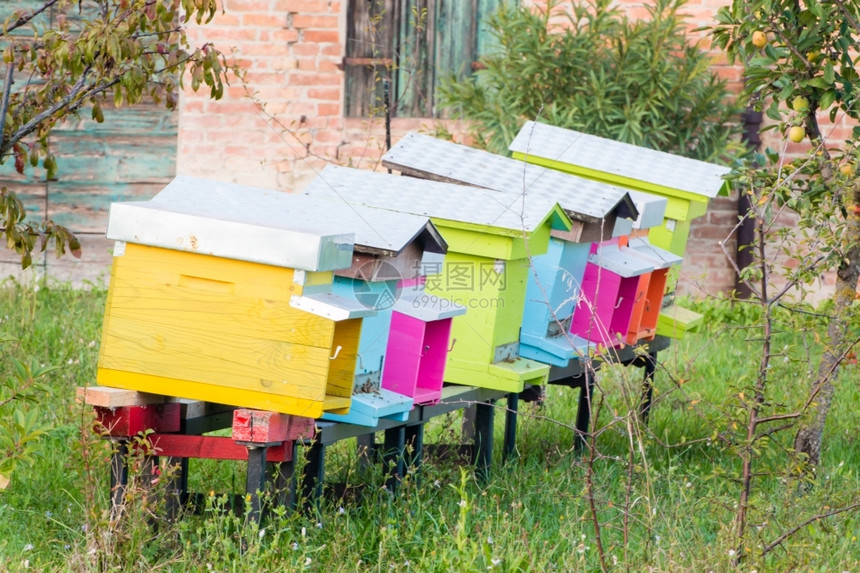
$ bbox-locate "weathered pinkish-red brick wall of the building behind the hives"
[177,0,847,302]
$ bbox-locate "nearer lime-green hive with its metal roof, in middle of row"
[306,163,570,392]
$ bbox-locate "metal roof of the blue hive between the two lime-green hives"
[382,132,638,223]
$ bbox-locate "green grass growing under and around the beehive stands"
[0,284,860,572]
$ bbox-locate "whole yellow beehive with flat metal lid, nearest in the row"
[98,178,372,417]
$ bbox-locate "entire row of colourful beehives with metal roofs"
[92,123,727,426]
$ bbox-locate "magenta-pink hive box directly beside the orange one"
[570,262,629,345]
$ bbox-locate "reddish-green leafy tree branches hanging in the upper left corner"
[0,0,229,267]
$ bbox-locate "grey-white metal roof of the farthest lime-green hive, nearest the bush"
[509,121,730,197]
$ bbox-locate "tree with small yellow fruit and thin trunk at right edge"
[713,0,860,468]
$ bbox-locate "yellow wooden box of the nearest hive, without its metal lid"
[98,244,361,415]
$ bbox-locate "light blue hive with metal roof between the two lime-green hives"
[383,133,635,366]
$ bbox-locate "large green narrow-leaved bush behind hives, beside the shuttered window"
[440,0,740,161]
